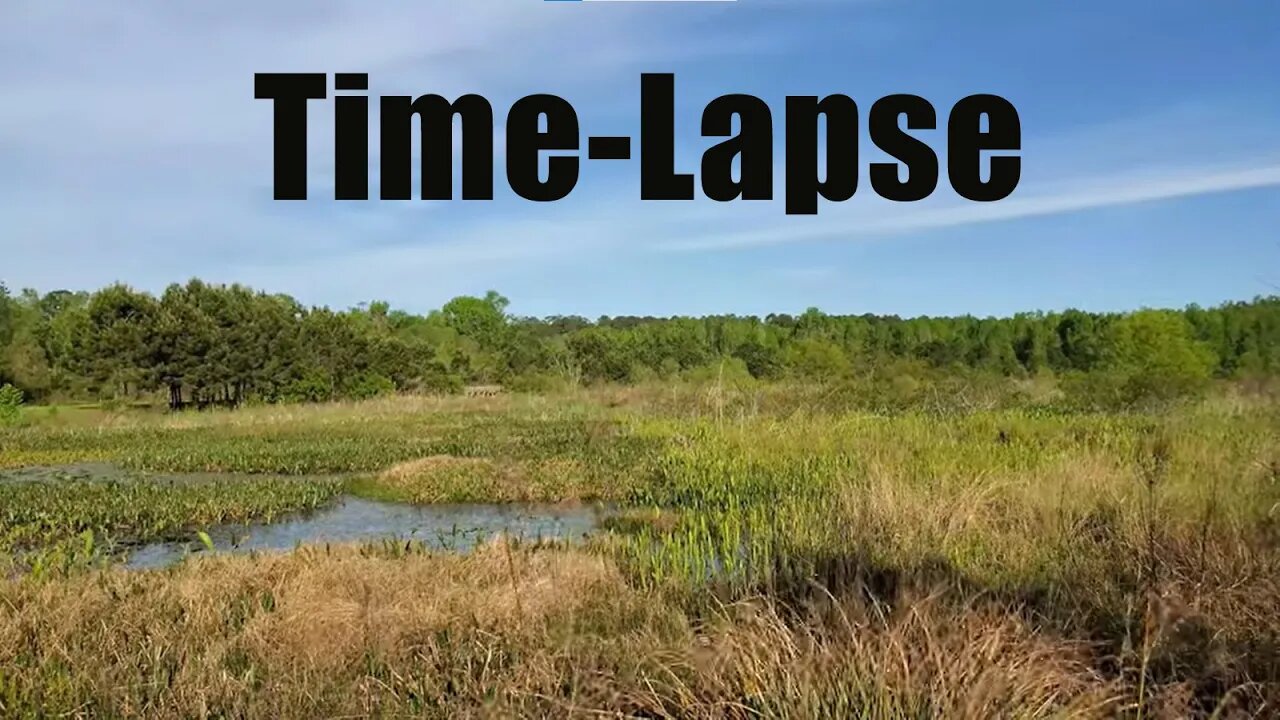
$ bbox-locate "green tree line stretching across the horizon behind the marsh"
[0,279,1280,407]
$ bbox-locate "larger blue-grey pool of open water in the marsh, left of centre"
[125,496,602,569]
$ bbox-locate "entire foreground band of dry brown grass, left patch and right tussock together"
[0,542,1157,719]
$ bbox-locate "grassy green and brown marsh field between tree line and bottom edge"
[0,388,1280,719]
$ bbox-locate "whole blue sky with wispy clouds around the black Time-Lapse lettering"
[0,0,1280,318]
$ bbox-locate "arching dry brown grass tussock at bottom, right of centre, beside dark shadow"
[680,596,1124,719]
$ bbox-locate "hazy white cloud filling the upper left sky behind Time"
[0,0,757,294]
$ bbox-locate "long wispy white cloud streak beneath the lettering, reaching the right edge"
[204,155,1280,310]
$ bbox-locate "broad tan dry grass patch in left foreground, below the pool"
[0,543,637,717]
